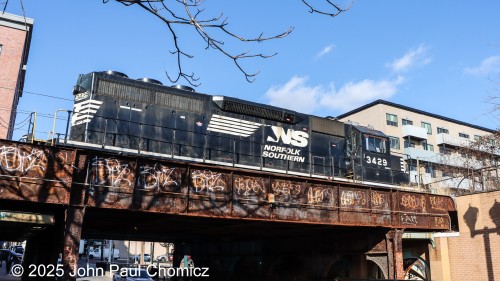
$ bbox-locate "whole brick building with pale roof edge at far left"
[0,13,33,139]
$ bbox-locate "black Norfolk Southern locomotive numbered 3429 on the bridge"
[70,71,408,184]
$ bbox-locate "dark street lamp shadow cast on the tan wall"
[464,199,500,281]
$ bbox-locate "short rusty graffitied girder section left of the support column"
[0,140,75,204]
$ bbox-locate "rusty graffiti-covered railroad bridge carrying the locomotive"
[0,140,455,280]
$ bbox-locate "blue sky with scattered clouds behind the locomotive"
[6,0,500,138]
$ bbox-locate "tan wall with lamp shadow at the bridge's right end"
[447,191,500,281]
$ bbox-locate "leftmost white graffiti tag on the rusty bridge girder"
[0,146,47,176]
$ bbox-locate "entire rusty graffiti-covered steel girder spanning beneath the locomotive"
[0,140,455,230]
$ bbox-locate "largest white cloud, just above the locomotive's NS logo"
[266,76,403,113]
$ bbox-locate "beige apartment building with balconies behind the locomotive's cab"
[337,100,500,191]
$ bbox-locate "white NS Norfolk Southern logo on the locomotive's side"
[262,126,309,162]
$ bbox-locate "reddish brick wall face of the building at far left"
[0,23,26,139]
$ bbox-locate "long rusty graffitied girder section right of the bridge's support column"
[80,149,455,230]
